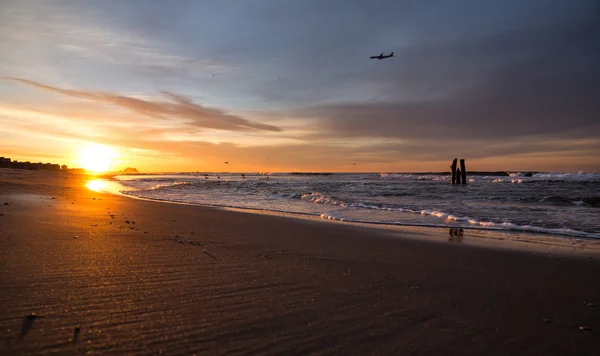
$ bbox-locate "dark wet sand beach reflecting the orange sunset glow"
[0,169,600,355]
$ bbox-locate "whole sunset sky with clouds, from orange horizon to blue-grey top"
[0,0,600,172]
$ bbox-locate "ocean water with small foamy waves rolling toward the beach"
[115,173,600,239]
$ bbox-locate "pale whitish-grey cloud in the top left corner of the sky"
[0,1,232,77]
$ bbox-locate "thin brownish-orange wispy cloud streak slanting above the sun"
[4,77,281,132]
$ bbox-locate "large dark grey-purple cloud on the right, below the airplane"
[290,16,600,145]
